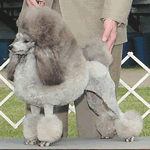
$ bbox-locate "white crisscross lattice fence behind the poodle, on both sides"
[0,52,150,129]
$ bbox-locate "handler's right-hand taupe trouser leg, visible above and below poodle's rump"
[75,45,122,138]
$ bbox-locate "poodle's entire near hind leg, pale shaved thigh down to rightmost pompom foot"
[86,61,143,141]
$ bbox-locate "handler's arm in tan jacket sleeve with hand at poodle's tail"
[101,0,132,52]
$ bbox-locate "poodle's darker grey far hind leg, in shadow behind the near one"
[86,92,117,139]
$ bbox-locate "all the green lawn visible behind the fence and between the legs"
[0,87,150,138]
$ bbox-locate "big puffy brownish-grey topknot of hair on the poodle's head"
[17,7,64,48]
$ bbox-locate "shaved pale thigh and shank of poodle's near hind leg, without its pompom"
[86,61,123,118]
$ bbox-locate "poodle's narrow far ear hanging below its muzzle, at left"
[7,53,20,81]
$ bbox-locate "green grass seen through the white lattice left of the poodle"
[0,88,25,138]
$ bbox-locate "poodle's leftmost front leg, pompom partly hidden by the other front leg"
[23,106,41,145]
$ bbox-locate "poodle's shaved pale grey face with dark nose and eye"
[8,33,35,55]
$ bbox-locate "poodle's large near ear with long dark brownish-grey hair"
[35,47,64,86]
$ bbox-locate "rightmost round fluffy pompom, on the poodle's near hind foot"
[115,111,143,138]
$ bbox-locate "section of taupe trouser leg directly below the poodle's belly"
[74,94,100,138]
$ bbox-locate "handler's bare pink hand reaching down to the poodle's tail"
[102,19,117,53]
